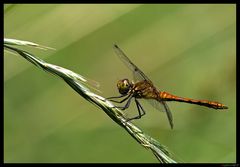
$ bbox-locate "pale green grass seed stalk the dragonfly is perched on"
[4,40,176,163]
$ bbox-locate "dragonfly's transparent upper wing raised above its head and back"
[114,44,152,83]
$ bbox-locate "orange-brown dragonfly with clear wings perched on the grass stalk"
[107,44,228,129]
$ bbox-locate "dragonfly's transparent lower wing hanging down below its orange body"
[146,99,173,128]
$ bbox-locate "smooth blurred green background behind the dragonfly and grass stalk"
[4,4,236,163]
